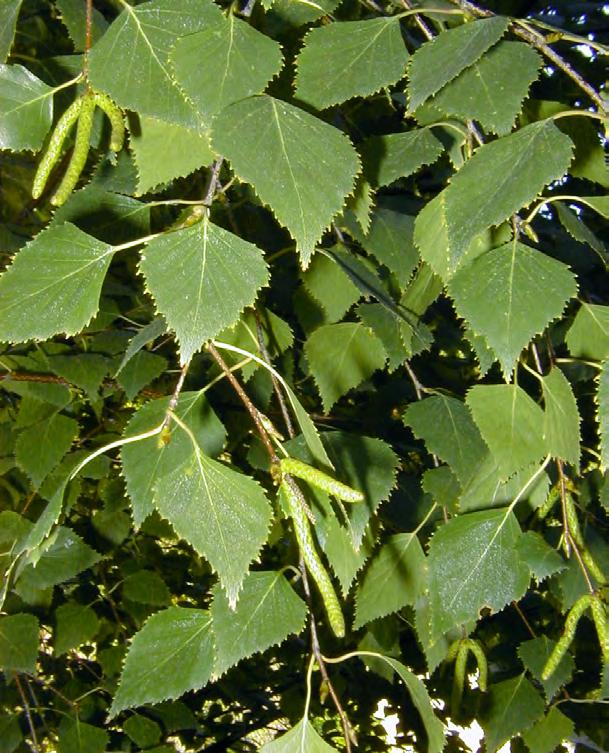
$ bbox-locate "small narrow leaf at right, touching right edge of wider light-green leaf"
[541,368,581,467]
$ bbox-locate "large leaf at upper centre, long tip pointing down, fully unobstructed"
[212,95,359,267]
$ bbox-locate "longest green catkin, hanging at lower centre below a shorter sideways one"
[281,480,345,638]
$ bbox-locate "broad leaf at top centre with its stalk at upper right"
[296,17,408,110]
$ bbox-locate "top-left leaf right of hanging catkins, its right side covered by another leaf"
[89,0,222,128]
